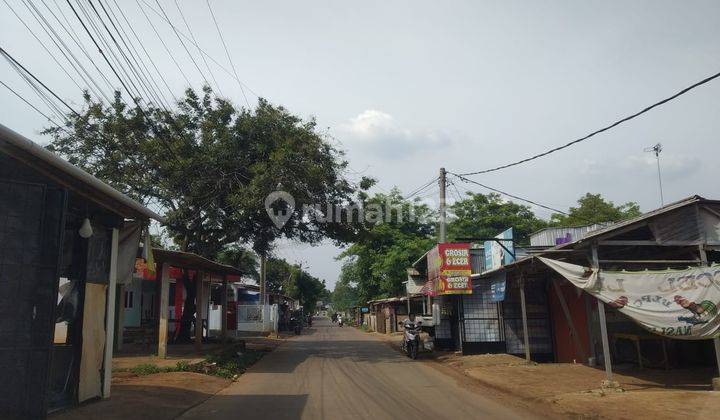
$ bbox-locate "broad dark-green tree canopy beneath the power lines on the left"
[44,87,356,258]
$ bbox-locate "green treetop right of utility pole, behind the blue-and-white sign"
[448,193,546,244]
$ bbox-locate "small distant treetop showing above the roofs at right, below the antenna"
[550,193,641,227]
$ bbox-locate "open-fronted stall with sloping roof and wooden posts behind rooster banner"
[473,196,720,379]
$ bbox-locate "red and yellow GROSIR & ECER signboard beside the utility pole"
[426,243,472,296]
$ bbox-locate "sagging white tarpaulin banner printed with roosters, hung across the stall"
[539,257,720,340]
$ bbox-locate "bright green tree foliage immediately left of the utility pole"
[338,189,435,302]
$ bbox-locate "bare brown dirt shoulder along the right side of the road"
[366,334,720,420]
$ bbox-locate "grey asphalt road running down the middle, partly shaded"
[181,319,528,420]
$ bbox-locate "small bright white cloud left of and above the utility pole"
[339,109,450,159]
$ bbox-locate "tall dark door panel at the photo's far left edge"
[0,181,66,418]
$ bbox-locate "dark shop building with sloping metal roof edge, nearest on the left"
[0,125,161,418]
